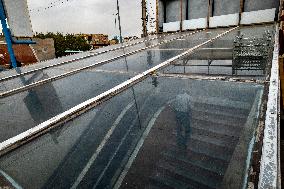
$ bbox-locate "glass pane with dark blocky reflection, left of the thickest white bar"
[0,71,133,142]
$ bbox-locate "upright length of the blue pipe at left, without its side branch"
[0,0,17,68]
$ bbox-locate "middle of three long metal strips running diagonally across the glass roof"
[0,31,204,98]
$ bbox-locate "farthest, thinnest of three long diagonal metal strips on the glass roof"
[0,28,193,82]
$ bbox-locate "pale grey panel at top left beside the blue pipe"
[3,0,33,37]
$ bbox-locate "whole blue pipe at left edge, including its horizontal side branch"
[0,0,35,68]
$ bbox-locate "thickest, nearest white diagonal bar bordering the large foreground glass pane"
[0,26,239,156]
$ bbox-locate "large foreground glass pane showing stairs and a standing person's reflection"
[0,77,263,188]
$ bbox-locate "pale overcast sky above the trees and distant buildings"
[28,0,155,37]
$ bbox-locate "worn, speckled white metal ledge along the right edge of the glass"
[258,26,281,189]
